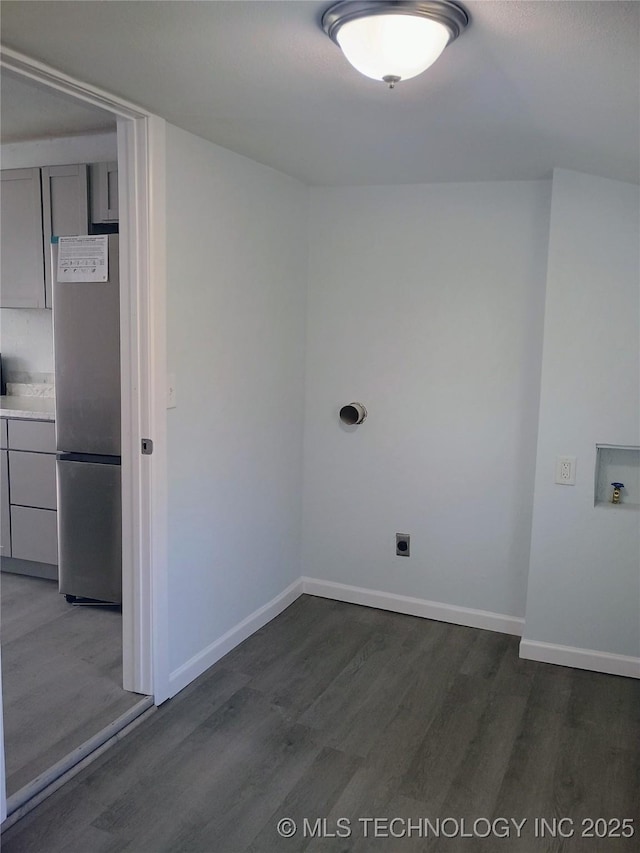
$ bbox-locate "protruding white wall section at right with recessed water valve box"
[525,170,640,657]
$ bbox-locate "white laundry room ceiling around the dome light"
[2,0,640,185]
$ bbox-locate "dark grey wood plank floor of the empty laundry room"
[2,596,640,853]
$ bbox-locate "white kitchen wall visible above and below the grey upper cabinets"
[0,130,117,378]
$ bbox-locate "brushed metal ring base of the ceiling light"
[322,0,469,44]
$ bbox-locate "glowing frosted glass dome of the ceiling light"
[336,15,450,80]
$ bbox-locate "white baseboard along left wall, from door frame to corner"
[169,579,303,696]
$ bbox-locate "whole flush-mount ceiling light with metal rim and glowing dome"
[322,0,469,89]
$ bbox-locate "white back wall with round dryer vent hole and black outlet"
[303,181,550,617]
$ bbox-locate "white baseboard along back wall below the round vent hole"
[302,577,524,637]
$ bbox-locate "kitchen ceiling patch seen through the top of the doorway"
[0,72,116,142]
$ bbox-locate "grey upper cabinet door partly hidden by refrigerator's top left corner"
[42,164,89,308]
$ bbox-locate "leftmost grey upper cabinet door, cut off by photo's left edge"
[0,169,45,308]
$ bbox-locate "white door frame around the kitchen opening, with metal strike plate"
[0,47,170,760]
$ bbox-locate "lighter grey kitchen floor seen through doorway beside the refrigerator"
[0,573,140,795]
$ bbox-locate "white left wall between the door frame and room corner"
[167,125,308,687]
